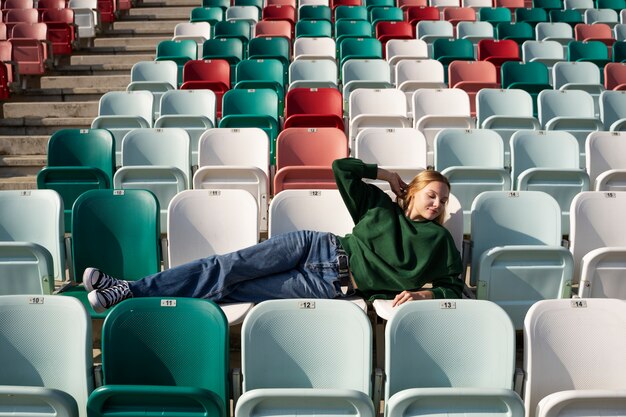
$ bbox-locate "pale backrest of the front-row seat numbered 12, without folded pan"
[241,299,372,395]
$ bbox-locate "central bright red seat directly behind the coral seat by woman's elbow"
[284,88,344,130]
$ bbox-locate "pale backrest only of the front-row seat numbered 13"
[385,300,515,402]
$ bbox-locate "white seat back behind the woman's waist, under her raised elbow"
[268,190,354,236]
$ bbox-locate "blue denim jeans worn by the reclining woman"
[129,231,336,301]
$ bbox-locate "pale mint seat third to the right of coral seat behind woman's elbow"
[511,130,589,236]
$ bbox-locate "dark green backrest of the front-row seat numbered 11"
[102,298,229,410]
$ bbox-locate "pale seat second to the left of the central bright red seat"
[154,90,216,166]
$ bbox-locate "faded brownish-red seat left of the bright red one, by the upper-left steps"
[9,23,50,75]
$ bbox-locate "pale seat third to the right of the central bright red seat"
[476,88,541,166]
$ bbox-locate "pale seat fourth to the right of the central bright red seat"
[537,90,604,166]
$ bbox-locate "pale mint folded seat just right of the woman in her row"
[470,191,574,330]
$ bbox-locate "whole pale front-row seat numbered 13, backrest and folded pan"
[385,300,524,417]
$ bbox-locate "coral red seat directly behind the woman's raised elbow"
[274,127,349,194]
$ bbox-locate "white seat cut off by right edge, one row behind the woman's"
[585,132,626,191]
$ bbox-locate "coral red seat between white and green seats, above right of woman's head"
[448,61,500,117]
